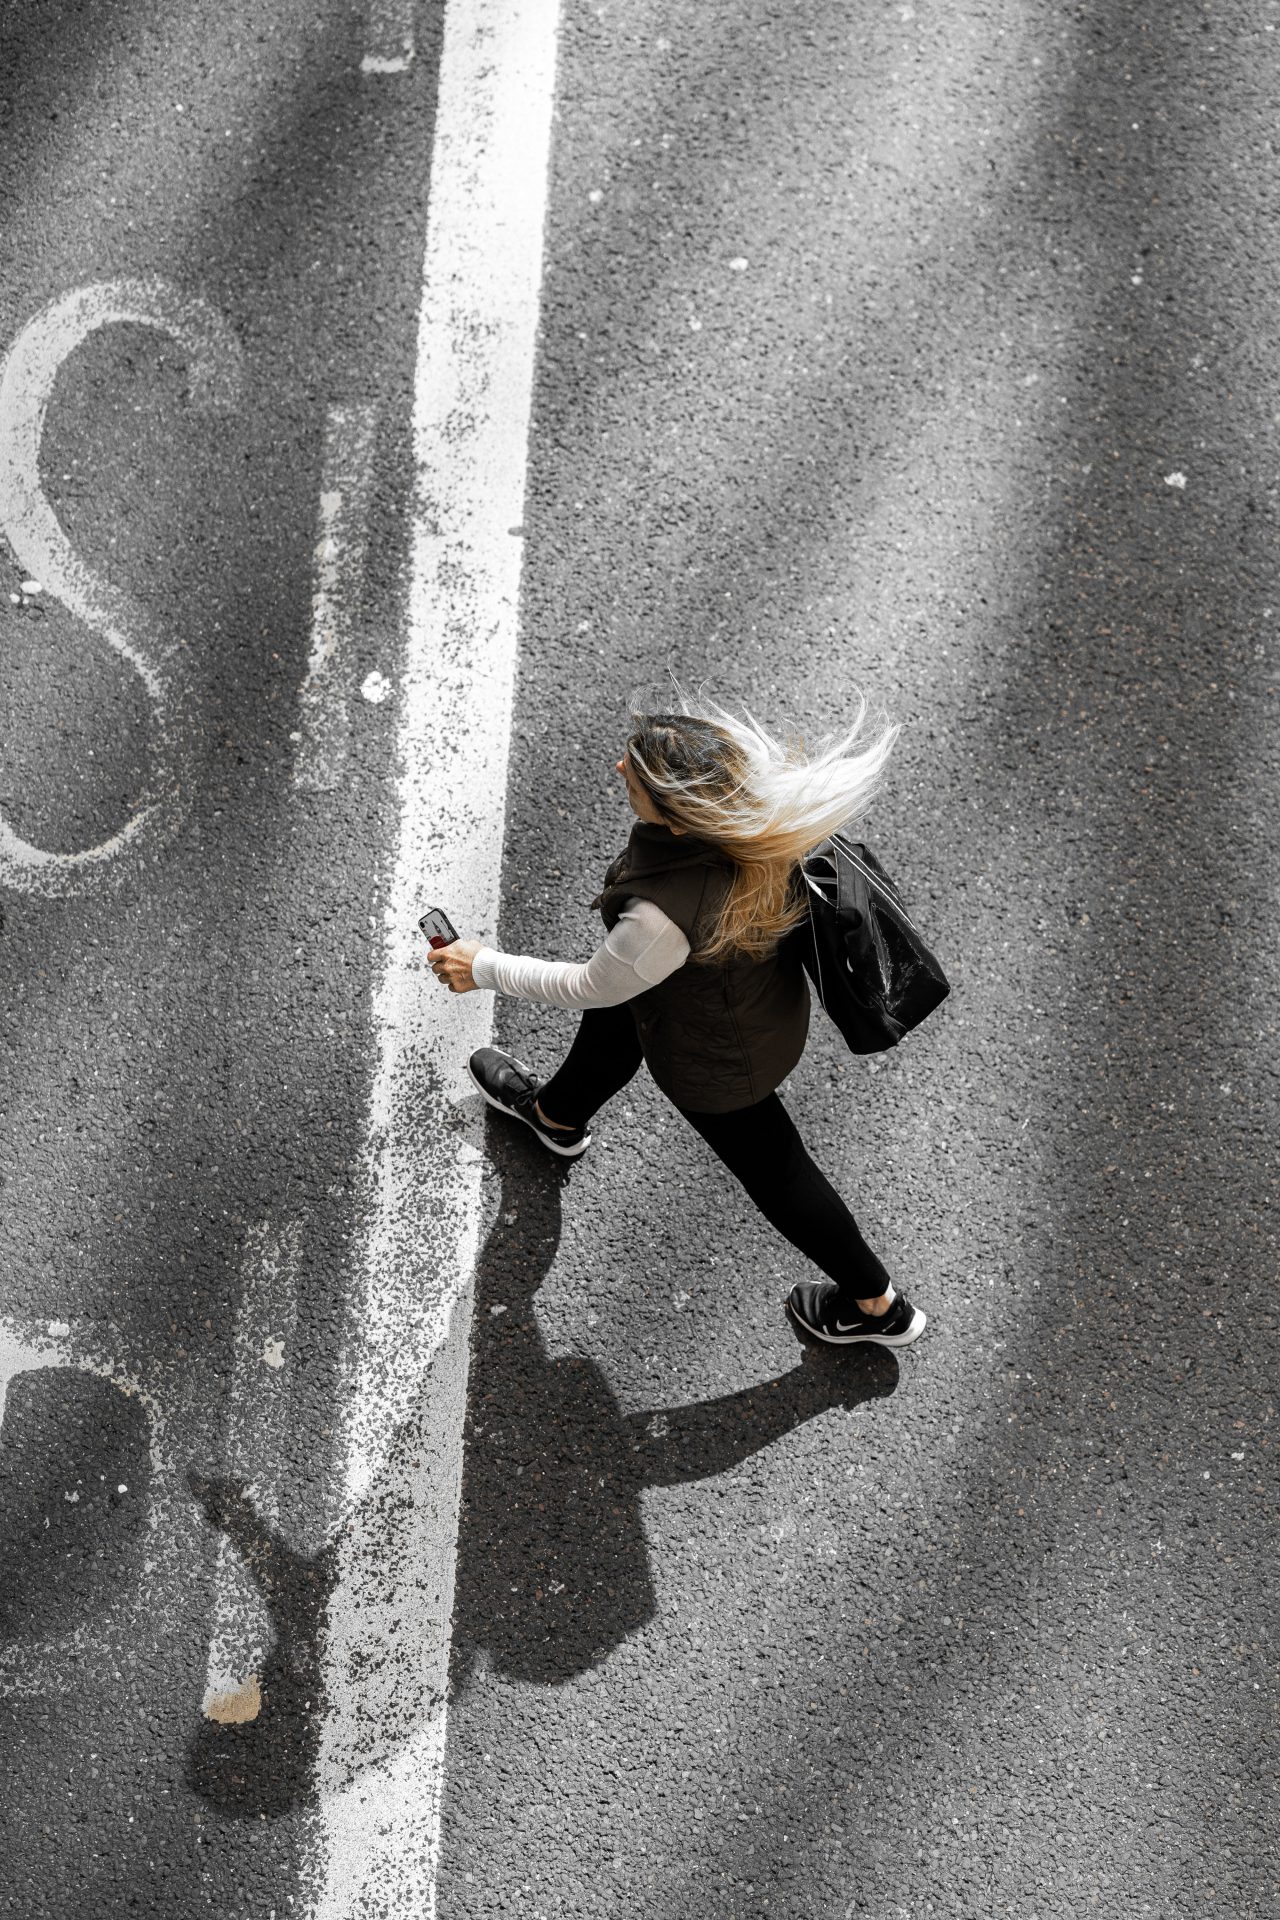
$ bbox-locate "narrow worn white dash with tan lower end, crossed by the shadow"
[203,1223,297,1722]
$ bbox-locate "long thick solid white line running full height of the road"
[313,0,557,1920]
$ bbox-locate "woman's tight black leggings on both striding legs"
[537,1002,889,1300]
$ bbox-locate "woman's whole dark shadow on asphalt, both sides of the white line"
[186,1113,898,1818]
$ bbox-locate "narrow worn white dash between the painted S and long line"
[294,407,378,793]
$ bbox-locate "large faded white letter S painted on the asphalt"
[0,280,242,895]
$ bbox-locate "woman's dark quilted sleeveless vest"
[591,820,810,1114]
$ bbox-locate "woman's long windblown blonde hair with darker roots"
[626,674,902,966]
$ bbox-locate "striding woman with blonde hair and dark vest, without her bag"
[430,685,925,1346]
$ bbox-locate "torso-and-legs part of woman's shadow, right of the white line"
[451,1123,898,1690]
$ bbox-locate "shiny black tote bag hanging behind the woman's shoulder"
[787,833,952,1054]
